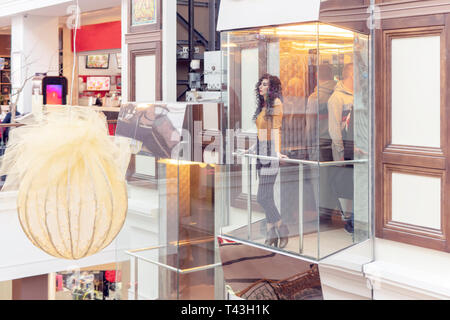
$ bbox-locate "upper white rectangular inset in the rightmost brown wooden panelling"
[392,36,441,148]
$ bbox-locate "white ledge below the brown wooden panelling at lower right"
[319,238,450,300]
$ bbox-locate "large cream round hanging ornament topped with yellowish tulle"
[0,107,130,259]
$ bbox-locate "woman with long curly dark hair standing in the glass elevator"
[253,74,289,248]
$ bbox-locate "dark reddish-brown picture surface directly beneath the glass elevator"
[219,237,323,300]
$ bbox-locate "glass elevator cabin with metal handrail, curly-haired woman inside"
[216,22,371,261]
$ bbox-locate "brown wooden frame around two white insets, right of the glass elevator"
[375,8,450,251]
